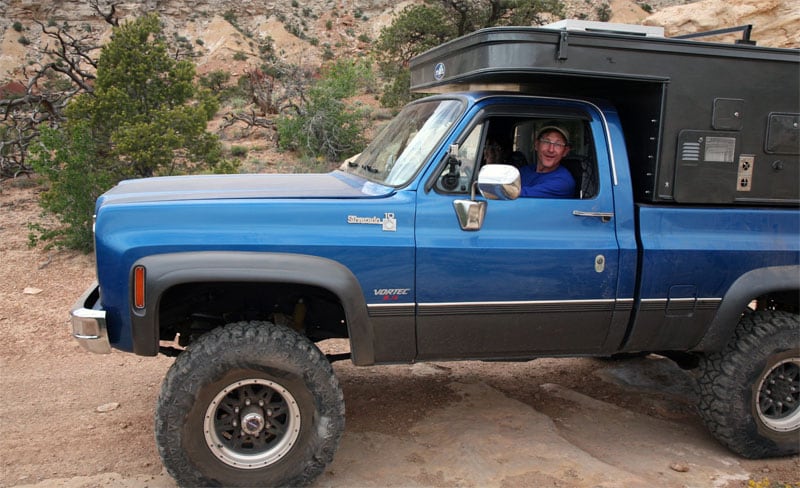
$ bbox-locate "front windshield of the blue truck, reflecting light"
[345,100,464,186]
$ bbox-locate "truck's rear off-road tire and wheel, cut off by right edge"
[697,311,800,458]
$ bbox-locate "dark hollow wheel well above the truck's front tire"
[158,281,348,353]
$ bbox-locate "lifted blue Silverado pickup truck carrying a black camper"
[71,22,800,486]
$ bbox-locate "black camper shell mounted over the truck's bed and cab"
[411,27,800,205]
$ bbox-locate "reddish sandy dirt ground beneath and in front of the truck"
[0,179,800,488]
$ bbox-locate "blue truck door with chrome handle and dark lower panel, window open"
[416,106,619,359]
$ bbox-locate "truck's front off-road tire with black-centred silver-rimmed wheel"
[155,322,344,486]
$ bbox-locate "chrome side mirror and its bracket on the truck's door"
[453,164,522,230]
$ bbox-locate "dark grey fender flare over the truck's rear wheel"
[693,265,800,352]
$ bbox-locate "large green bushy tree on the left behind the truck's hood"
[31,15,236,251]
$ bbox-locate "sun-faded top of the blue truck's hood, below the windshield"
[98,171,395,205]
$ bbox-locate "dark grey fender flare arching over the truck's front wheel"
[129,251,375,366]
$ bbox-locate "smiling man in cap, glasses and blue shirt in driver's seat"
[519,125,575,198]
